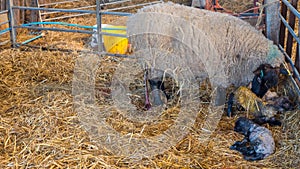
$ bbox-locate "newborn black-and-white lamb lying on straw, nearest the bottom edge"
[230,117,275,161]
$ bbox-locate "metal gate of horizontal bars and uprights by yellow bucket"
[0,0,162,56]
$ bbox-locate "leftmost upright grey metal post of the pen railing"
[7,0,17,48]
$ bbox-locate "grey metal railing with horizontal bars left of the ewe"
[0,0,162,57]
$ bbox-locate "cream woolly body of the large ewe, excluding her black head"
[127,3,284,115]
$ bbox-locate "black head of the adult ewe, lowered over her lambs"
[251,64,288,98]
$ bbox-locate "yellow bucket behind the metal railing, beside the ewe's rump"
[102,24,128,54]
